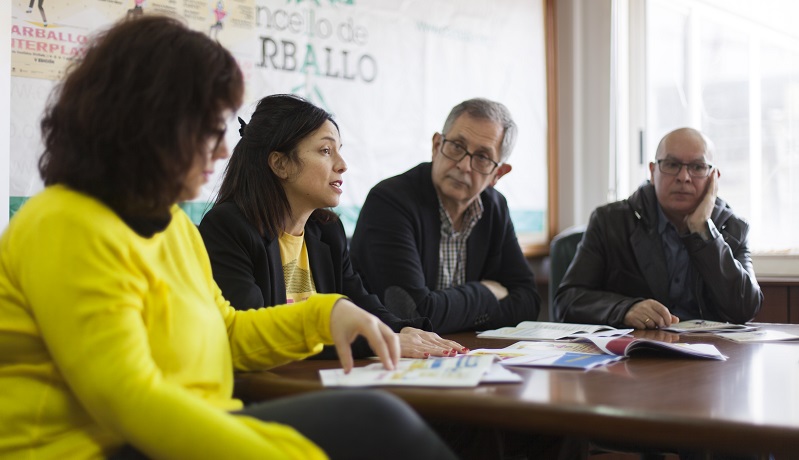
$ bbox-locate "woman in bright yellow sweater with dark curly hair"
[0,16,460,459]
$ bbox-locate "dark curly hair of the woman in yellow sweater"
[39,16,244,218]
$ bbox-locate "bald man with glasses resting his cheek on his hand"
[555,128,763,329]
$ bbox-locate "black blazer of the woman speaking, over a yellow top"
[200,202,431,356]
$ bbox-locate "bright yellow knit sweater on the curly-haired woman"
[0,186,340,459]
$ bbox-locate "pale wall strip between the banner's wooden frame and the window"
[556,0,612,231]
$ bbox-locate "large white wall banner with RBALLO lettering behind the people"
[10,0,550,244]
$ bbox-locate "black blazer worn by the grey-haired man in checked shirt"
[352,163,541,334]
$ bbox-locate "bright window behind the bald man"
[644,0,799,253]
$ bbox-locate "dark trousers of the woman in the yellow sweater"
[111,390,457,460]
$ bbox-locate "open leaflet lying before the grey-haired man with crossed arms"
[477,321,633,340]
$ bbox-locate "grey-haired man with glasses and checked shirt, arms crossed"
[351,99,541,334]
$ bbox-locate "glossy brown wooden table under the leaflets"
[236,324,799,459]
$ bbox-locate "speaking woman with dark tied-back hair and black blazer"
[200,94,466,358]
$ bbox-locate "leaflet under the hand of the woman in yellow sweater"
[319,355,495,387]
